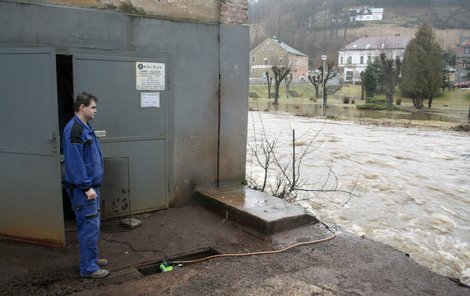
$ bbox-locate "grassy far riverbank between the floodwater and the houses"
[248,83,470,125]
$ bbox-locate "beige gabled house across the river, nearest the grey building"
[250,37,308,79]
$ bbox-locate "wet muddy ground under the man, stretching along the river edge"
[0,204,470,295]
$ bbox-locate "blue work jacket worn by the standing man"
[64,115,104,191]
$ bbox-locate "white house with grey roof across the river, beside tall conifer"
[338,36,411,83]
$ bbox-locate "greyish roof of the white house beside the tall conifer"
[341,36,411,50]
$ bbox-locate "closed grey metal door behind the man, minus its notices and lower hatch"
[73,54,168,213]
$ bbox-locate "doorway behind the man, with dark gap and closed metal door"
[56,53,168,222]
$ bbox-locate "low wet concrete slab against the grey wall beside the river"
[196,184,318,235]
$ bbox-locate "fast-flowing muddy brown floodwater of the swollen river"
[246,112,470,285]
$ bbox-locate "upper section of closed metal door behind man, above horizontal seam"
[73,55,166,139]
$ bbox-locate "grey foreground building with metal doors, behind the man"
[0,0,249,246]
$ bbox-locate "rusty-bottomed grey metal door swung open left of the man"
[0,48,65,246]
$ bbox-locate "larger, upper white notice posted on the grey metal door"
[135,62,165,90]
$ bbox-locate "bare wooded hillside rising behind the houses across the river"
[248,0,470,66]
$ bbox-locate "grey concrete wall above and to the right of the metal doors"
[0,1,249,206]
